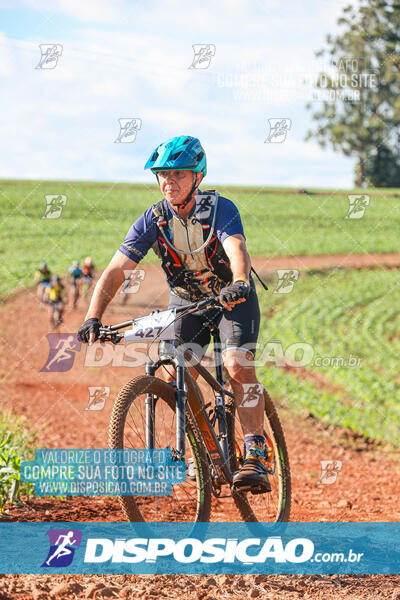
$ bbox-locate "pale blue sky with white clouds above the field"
[0,0,354,189]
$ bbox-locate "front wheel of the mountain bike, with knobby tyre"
[109,376,211,523]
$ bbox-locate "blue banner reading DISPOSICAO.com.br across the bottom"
[0,523,400,574]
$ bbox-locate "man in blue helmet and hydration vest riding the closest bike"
[79,136,271,491]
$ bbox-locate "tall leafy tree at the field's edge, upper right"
[306,0,400,187]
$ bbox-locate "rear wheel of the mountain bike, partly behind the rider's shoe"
[226,390,291,522]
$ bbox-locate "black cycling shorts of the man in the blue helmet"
[169,281,260,359]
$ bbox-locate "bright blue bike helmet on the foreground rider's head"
[144,135,207,177]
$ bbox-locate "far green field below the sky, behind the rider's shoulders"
[0,180,400,296]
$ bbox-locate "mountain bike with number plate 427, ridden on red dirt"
[99,297,291,523]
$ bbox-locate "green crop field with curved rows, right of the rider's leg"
[259,270,400,444]
